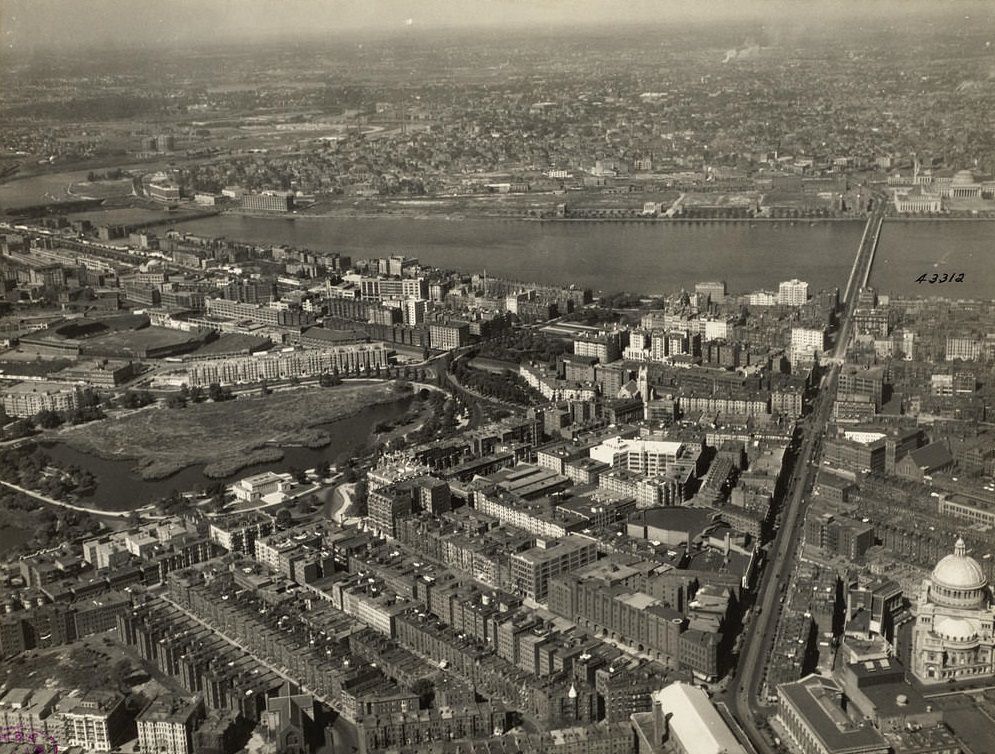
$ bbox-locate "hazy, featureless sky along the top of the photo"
[0,0,995,55]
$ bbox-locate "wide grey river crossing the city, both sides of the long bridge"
[177,214,995,298]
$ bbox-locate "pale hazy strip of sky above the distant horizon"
[7,0,995,54]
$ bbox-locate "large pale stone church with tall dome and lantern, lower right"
[912,538,995,683]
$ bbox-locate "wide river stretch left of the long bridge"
[177,215,863,294]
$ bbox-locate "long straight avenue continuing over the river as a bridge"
[725,203,884,754]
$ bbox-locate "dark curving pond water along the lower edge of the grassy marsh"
[44,399,410,510]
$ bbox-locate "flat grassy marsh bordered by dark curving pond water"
[59,383,409,479]
